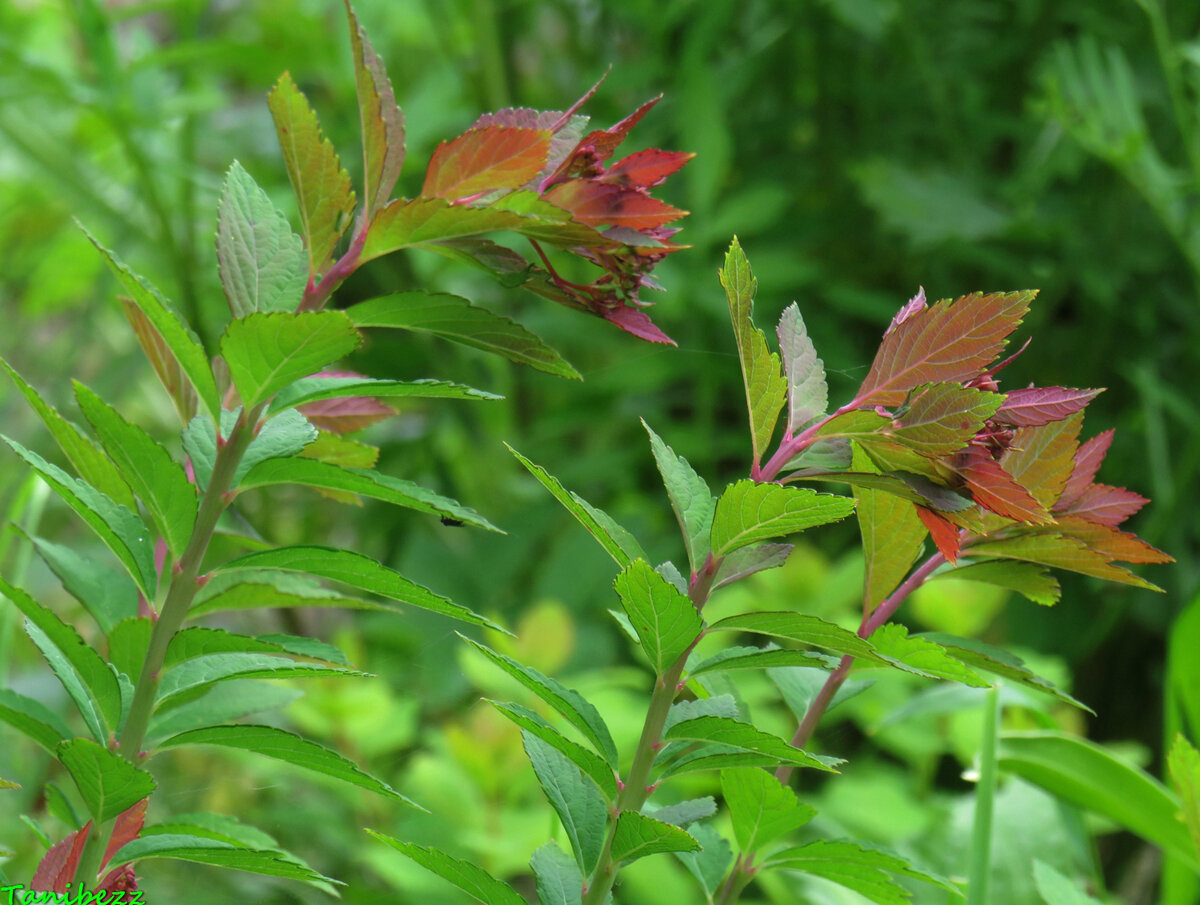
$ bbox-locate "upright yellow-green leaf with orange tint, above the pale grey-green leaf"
[266,72,354,274]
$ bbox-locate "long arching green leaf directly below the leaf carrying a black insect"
[217,546,509,634]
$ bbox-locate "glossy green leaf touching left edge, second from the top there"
[4,437,158,600]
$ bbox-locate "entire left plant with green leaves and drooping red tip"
[0,4,691,892]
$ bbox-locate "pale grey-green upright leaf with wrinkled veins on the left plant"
[217,161,308,318]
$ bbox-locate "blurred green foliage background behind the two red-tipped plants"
[0,0,1200,905]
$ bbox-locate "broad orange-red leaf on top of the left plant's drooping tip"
[421,126,551,199]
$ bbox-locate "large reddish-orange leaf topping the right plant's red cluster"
[853,292,1034,408]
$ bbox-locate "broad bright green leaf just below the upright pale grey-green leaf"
[221,311,361,408]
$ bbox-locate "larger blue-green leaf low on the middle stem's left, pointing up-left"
[521,731,608,876]
